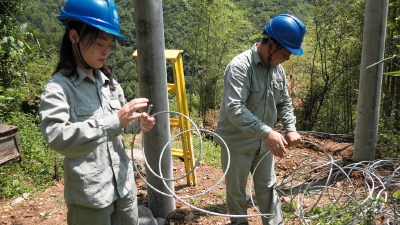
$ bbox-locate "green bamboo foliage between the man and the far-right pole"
[289,0,364,133]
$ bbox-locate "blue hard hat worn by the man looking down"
[264,14,306,55]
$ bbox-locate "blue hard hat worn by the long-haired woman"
[57,0,126,39]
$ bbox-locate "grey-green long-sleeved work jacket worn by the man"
[214,43,296,153]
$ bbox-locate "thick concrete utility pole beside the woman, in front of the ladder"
[134,0,175,218]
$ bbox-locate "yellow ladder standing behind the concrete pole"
[132,49,197,185]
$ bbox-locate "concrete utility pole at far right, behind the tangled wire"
[353,0,389,162]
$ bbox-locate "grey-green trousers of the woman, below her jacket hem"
[67,183,139,225]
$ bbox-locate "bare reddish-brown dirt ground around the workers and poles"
[0,133,353,225]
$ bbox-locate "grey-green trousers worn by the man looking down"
[221,146,283,225]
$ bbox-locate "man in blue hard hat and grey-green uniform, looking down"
[214,14,306,225]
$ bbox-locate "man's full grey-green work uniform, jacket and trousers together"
[214,43,296,225]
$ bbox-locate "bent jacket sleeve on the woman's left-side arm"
[39,83,122,158]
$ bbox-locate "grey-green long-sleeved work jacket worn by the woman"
[39,67,139,224]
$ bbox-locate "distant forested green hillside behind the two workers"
[18,0,311,100]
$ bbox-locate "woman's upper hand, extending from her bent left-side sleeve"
[117,98,150,128]
